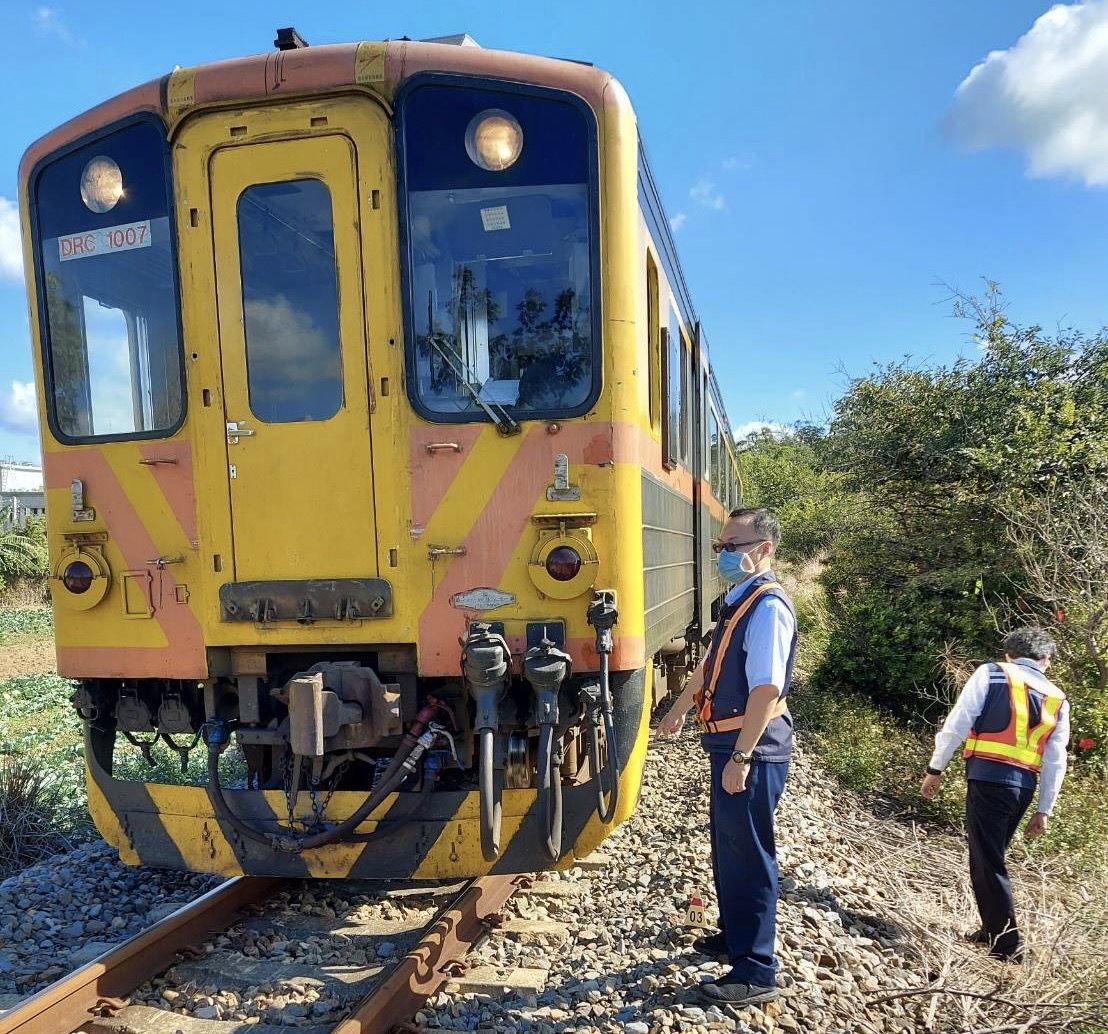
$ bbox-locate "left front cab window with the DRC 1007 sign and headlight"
[32,121,184,441]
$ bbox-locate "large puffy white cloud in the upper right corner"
[948,0,1108,186]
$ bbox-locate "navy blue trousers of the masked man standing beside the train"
[709,754,789,987]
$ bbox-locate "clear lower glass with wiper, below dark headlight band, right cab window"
[410,184,593,414]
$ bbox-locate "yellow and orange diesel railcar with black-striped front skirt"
[20,30,739,878]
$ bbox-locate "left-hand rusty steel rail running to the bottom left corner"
[0,877,288,1034]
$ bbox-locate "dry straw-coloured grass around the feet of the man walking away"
[824,793,1108,1034]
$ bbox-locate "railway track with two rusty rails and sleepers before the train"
[0,876,527,1034]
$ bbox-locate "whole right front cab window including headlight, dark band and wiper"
[403,85,599,422]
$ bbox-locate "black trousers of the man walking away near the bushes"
[966,779,1035,955]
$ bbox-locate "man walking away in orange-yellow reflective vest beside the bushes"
[920,628,1069,962]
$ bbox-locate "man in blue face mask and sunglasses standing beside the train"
[658,508,797,1005]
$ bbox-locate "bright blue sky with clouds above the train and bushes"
[0,0,1108,458]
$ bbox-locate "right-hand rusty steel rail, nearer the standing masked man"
[330,876,527,1034]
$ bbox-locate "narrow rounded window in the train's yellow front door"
[232,180,342,423]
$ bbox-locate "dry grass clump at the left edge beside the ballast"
[0,757,71,879]
